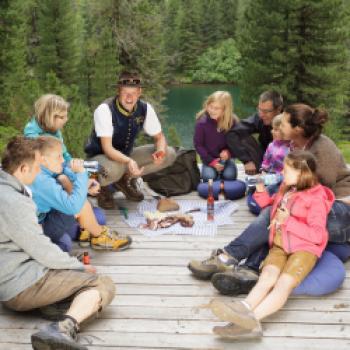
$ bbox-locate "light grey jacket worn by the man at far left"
[0,170,84,301]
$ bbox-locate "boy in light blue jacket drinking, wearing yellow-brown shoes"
[31,136,131,251]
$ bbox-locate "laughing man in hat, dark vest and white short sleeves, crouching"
[85,72,175,209]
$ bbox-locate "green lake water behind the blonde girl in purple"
[164,84,249,148]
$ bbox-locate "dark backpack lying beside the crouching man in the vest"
[143,148,200,197]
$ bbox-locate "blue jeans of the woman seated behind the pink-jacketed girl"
[224,201,350,271]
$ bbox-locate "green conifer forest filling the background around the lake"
[0,0,350,161]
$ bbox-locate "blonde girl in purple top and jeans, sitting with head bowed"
[193,91,238,182]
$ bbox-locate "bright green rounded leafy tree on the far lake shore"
[192,39,241,83]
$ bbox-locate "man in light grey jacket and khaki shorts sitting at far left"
[0,136,115,350]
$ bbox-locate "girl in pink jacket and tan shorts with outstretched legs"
[211,150,335,337]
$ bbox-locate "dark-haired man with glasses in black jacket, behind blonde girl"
[227,91,283,175]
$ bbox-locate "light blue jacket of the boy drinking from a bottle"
[30,166,88,223]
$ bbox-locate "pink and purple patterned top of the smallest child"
[261,140,290,174]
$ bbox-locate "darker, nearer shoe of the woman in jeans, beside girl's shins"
[211,266,259,295]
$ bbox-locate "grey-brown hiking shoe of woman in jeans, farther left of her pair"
[188,249,238,280]
